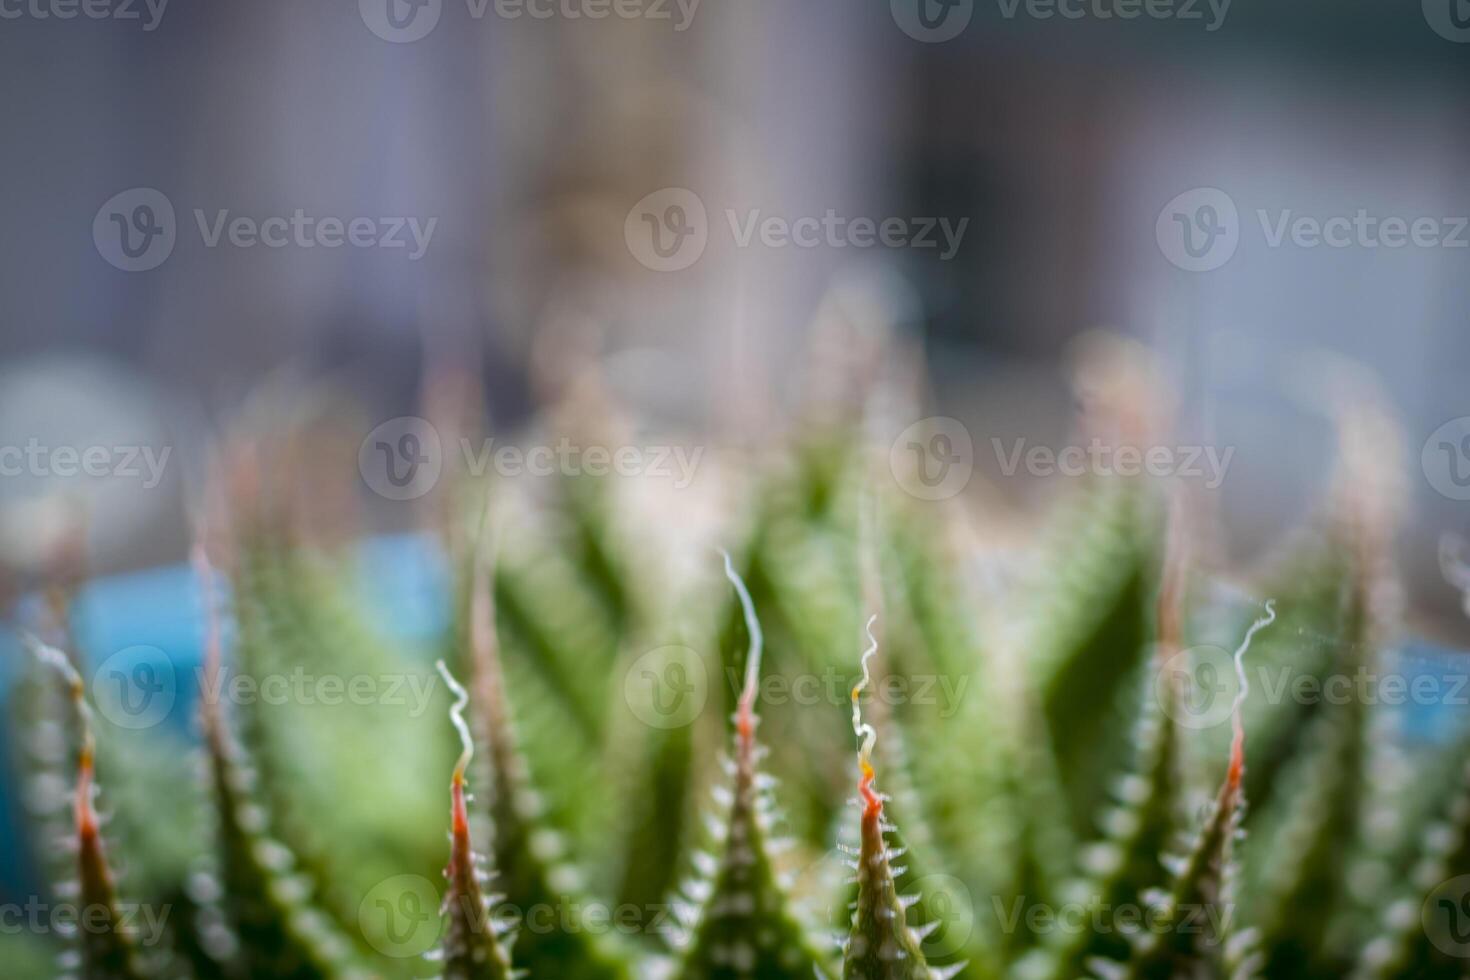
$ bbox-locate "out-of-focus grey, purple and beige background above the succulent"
[0,0,1470,628]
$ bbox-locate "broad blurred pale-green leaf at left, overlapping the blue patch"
[229,535,450,934]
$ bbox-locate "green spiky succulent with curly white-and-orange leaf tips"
[0,365,1470,980]
